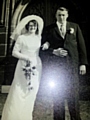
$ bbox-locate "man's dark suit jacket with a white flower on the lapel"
[42,22,88,65]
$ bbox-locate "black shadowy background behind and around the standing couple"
[0,0,90,99]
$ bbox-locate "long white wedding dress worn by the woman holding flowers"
[1,35,42,120]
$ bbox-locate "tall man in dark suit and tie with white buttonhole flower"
[42,7,88,120]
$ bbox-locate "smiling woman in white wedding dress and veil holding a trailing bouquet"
[1,15,43,120]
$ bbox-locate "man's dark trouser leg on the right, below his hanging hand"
[67,65,81,120]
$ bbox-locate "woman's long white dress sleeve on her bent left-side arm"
[12,37,29,60]
